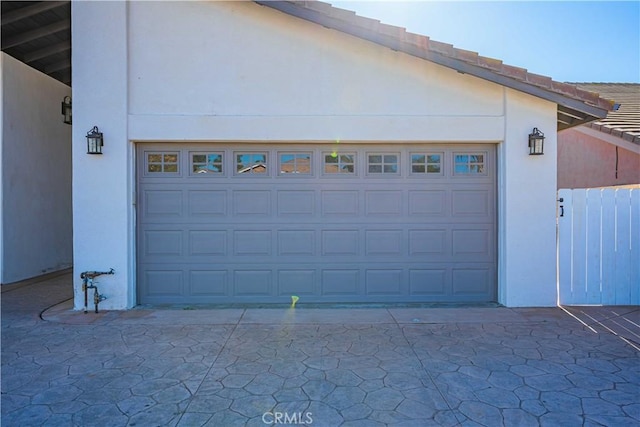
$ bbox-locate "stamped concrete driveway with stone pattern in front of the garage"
[1,273,640,427]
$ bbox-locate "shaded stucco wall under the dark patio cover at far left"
[0,53,72,283]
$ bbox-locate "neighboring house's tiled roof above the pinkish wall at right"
[574,83,640,145]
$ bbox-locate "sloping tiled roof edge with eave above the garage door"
[255,0,613,130]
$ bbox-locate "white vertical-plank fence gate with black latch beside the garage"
[558,188,640,305]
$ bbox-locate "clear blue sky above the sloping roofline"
[324,0,640,83]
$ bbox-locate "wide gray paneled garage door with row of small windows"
[137,143,497,304]
